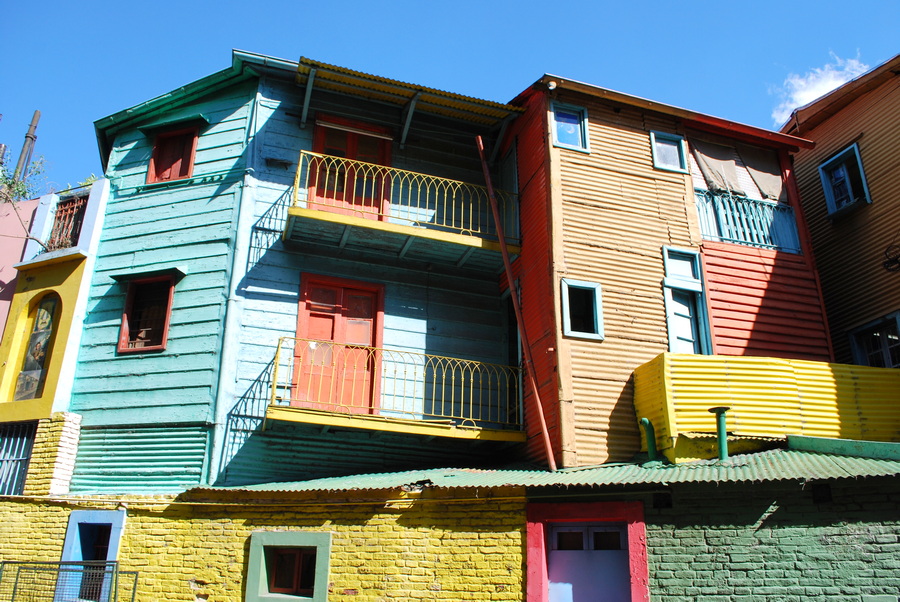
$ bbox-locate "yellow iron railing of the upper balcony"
[293,151,519,244]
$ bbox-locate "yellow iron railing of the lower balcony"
[270,337,522,429]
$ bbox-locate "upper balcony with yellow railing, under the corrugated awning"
[284,151,519,273]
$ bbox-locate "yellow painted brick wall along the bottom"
[0,490,525,602]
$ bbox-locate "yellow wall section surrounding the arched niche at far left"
[0,256,84,422]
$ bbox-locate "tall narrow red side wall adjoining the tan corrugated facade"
[507,94,562,464]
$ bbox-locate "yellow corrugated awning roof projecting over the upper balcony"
[297,57,524,126]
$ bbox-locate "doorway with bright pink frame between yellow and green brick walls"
[526,502,649,602]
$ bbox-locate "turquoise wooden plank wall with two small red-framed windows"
[71,82,256,488]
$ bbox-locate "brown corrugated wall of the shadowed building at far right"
[794,77,900,363]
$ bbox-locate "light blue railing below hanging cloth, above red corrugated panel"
[695,190,800,253]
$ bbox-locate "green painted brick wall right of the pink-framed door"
[645,478,900,602]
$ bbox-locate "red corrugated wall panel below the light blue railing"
[702,241,830,362]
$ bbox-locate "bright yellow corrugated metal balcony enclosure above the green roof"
[634,353,900,462]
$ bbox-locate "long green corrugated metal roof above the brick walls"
[202,449,900,492]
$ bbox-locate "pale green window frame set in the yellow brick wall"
[244,531,331,602]
